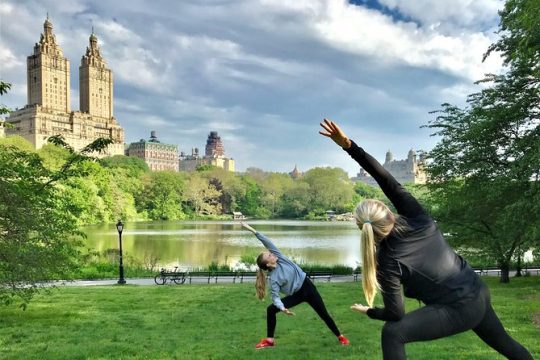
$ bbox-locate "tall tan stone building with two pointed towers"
[5,17,124,156]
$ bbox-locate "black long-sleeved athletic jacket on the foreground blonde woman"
[345,142,480,321]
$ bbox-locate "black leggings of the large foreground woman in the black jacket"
[382,284,532,360]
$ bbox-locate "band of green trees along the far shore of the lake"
[0,136,434,225]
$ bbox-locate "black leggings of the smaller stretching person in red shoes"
[266,276,340,338]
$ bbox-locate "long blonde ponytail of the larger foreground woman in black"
[361,222,380,307]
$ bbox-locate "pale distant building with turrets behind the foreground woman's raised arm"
[351,149,427,186]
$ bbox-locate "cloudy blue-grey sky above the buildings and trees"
[0,0,504,176]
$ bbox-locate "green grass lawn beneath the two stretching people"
[0,276,540,360]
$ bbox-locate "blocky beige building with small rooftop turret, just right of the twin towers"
[126,131,178,171]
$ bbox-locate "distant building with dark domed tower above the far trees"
[178,131,234,172]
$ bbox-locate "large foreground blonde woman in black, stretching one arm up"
[320,119,532,360]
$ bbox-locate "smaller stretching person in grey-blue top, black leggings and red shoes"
[242,223,349,349]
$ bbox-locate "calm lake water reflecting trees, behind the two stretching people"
[84,220,360,269]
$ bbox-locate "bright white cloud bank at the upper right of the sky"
[310,1,500,80]
